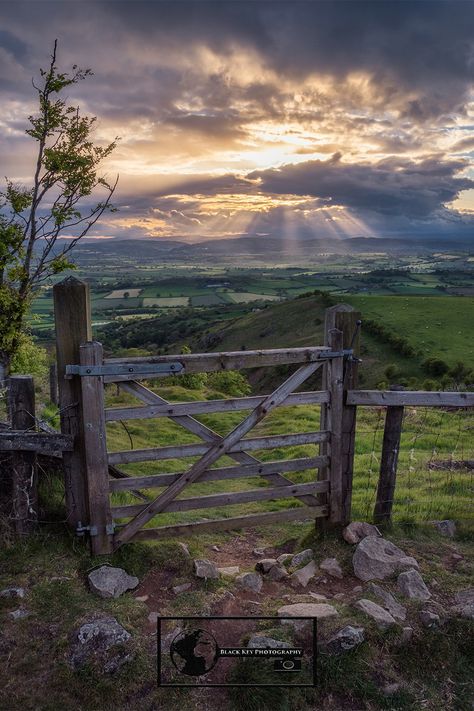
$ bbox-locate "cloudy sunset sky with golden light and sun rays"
[0,0,474,241]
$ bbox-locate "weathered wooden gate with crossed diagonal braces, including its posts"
[55,279,356,553]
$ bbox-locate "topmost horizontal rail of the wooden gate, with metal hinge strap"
[104,346,328,383]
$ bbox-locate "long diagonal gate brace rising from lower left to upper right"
[114,362,321,547]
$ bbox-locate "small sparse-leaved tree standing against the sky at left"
[0,40,118,381]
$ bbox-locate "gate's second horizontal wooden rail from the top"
[105,390,330,422]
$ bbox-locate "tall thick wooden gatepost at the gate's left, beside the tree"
[53,277,92,528]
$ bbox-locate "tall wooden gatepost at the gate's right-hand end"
[320,304,360,524]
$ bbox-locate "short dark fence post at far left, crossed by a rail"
[9,375,38,534]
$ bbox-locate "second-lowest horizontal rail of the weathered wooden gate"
[112,481,329,518]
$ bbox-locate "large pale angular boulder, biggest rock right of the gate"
[352,536,418,580]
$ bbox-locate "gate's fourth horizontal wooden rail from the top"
[109,456,329,491]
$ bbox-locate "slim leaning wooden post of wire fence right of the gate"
[374,405,404,523]
